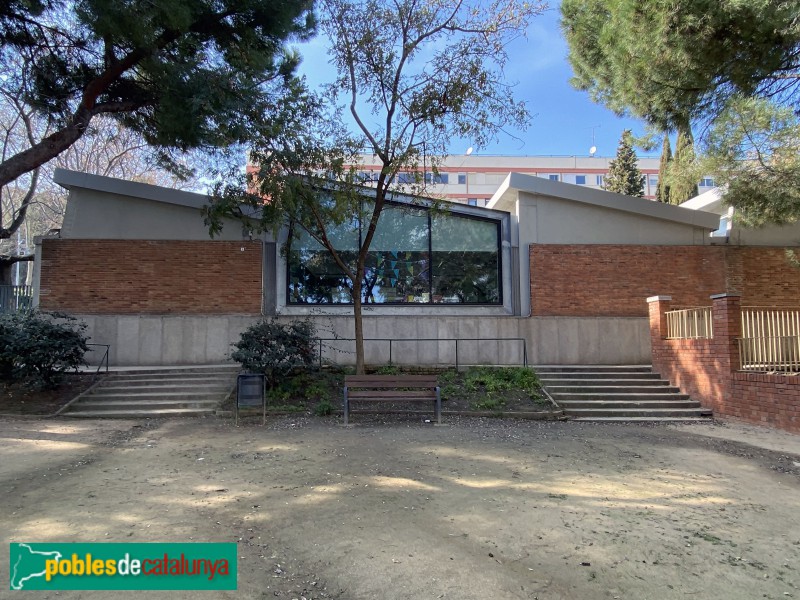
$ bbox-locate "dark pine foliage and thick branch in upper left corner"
[0,0,313,191]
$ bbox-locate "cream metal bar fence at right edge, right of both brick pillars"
[739,307,800,371]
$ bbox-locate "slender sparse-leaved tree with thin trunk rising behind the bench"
[207,0,544,373]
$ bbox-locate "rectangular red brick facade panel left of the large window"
[39,239,262,314]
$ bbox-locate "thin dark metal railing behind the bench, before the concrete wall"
[317,338,528,369]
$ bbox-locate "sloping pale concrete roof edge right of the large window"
[487,173,719,231]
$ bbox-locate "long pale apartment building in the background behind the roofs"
[359,154,714,206]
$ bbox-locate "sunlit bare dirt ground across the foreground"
[0,416,800,600]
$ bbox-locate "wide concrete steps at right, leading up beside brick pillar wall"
[534,365,711,421]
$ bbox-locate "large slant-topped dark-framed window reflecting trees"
[287,198,502,305]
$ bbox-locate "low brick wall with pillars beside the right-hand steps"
[649,295,800,433]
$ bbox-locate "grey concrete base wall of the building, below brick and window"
[76,315,650,366]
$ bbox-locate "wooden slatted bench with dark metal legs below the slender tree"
[344,375,442,425]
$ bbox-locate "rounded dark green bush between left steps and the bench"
[231,319,317,387]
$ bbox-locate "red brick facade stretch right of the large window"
[530,244,800,317]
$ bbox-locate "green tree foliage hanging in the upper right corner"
[561,0,800,224]
